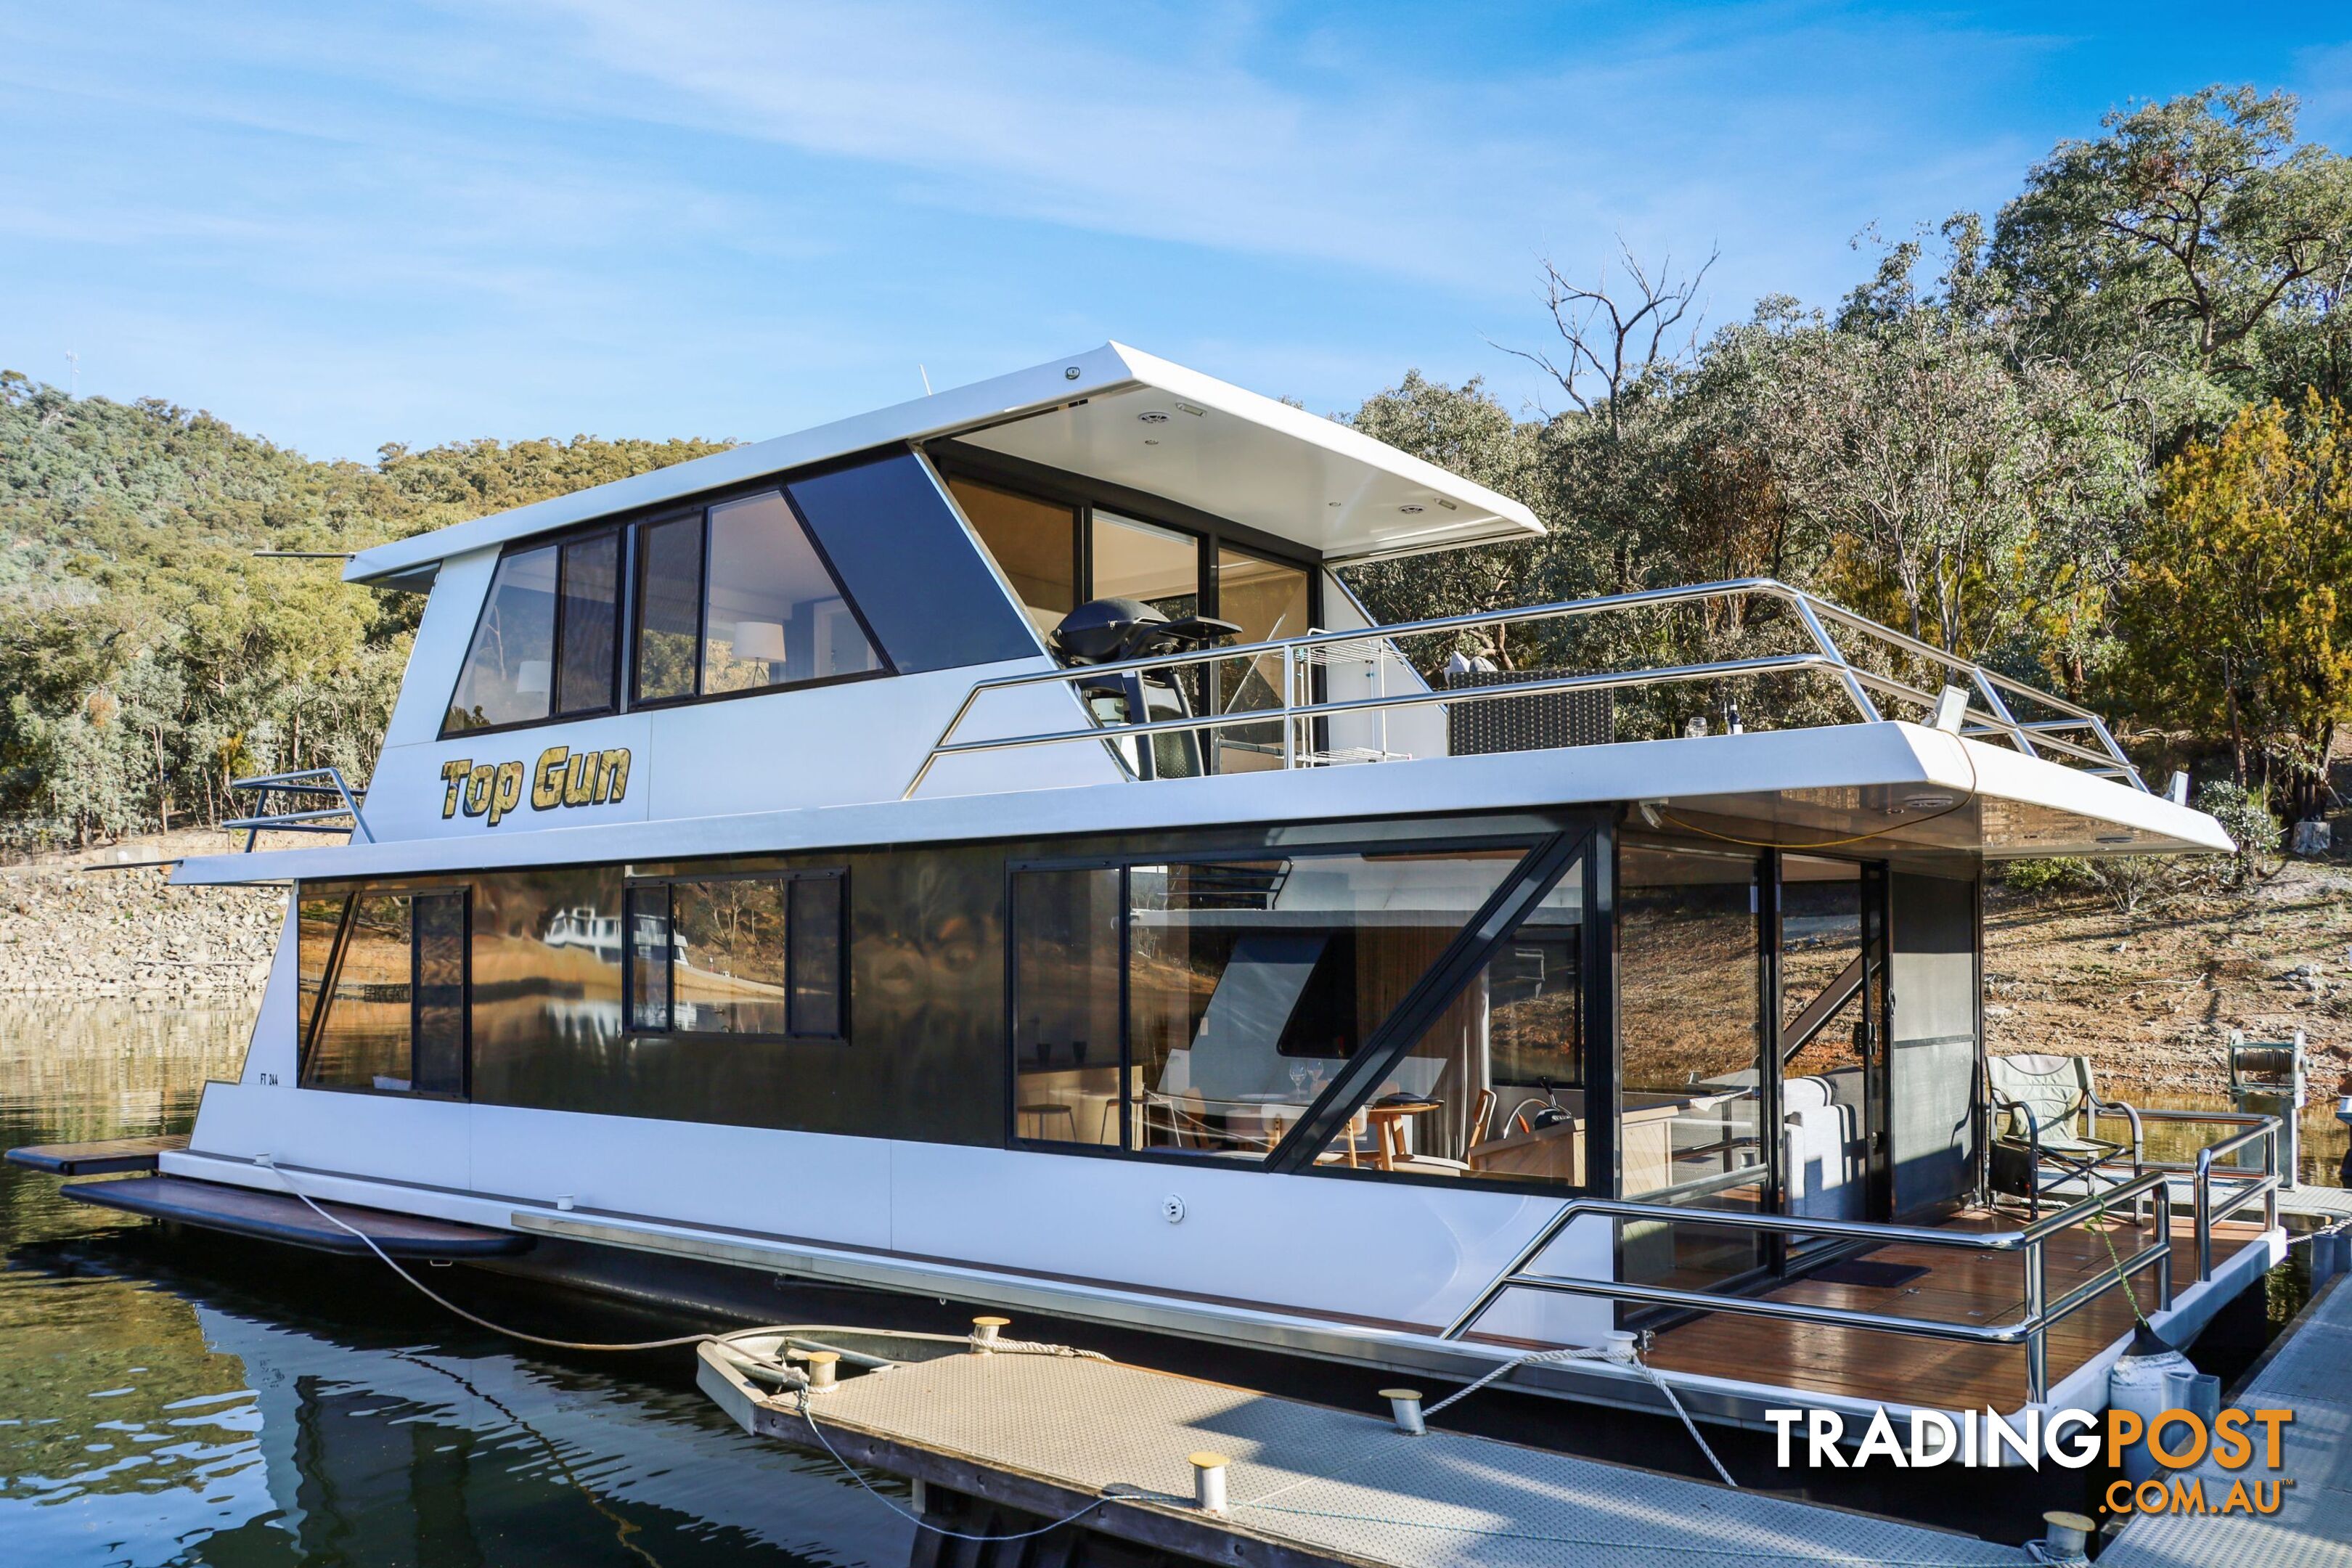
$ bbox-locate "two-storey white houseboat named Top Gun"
[9,343,2284,1457]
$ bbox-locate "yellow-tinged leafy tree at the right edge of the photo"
[2119,393,2352,813]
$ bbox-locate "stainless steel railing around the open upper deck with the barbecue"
[905,579,2147,799]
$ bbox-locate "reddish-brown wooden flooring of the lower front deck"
[1649,1213,2263,1410]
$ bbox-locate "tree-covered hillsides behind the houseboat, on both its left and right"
[0,89,2352,844]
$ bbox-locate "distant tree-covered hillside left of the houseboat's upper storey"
[0,372,719,846]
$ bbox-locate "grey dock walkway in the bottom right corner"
[2098,1279,2352,1568]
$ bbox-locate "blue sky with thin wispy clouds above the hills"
[0,0,2352,458]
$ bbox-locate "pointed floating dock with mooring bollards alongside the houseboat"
[701,1352,2028,1568]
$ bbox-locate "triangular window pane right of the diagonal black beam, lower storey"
[1317,860,1588,1185]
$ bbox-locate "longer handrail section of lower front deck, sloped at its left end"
[1440,1170,2173,1403]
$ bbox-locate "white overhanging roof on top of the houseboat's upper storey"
[343,343,1543,583]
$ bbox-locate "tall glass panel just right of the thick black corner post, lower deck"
[1618,839,1764,1289]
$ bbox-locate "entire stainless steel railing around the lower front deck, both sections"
[1440,1112,2279,1403]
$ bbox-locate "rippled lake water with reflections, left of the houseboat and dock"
[0,1004,908,1568]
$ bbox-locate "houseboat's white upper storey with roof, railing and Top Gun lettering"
[179,343,2227,881]
